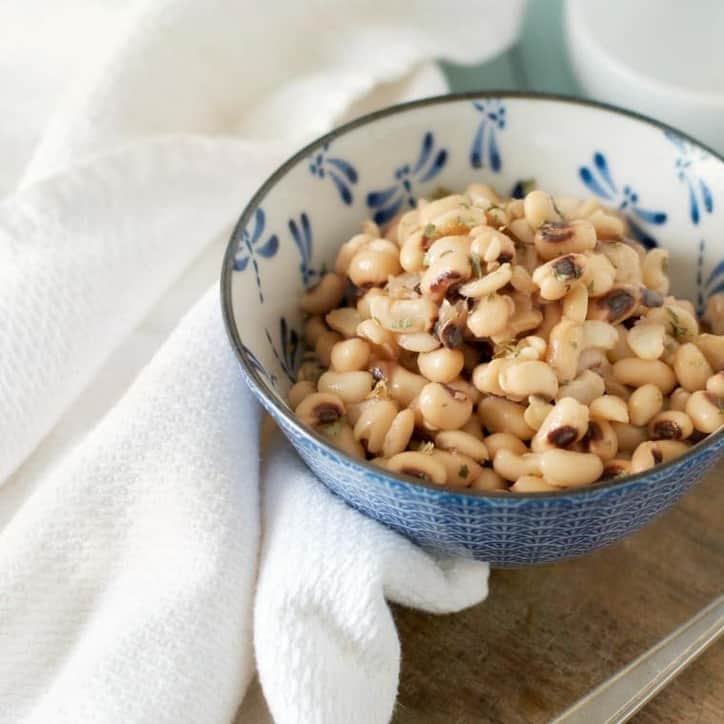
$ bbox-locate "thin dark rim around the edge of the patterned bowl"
[220,90,724,503]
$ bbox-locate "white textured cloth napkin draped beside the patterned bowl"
[0,0,520,724]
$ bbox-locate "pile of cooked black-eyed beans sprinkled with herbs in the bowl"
[289,184,724,492]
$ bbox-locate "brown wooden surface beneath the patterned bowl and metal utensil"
[393,464,724,724]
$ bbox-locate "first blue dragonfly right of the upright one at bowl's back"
[578,151,667,249]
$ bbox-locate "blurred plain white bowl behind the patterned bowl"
[565,0,724,152]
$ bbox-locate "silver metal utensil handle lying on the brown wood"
[551,596,724,724]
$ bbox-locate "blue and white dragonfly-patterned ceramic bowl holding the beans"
[222,93,724,566]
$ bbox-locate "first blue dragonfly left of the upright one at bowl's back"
[367,131,448,224]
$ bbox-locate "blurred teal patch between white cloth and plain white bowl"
[441,0,584,96]
